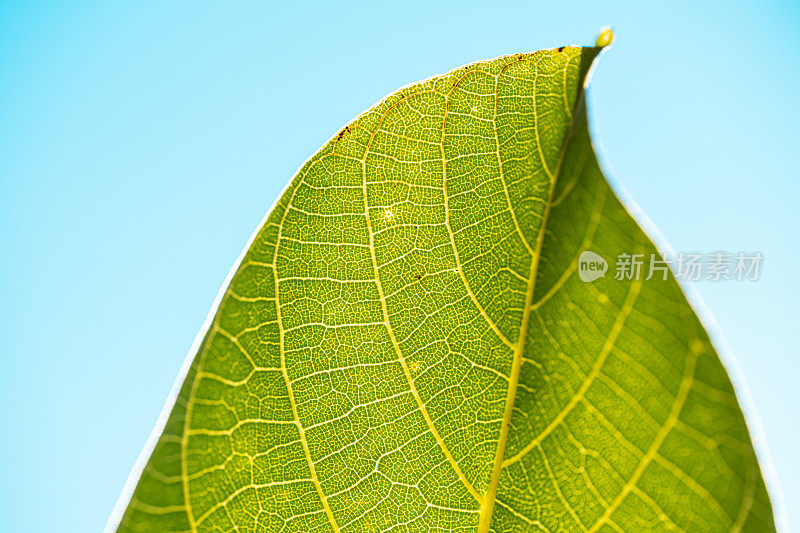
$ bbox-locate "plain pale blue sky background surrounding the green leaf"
[0,1,800,532]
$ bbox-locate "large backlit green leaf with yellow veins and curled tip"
[111,38,775,532]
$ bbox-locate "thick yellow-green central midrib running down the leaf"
[478,96,584,533]
